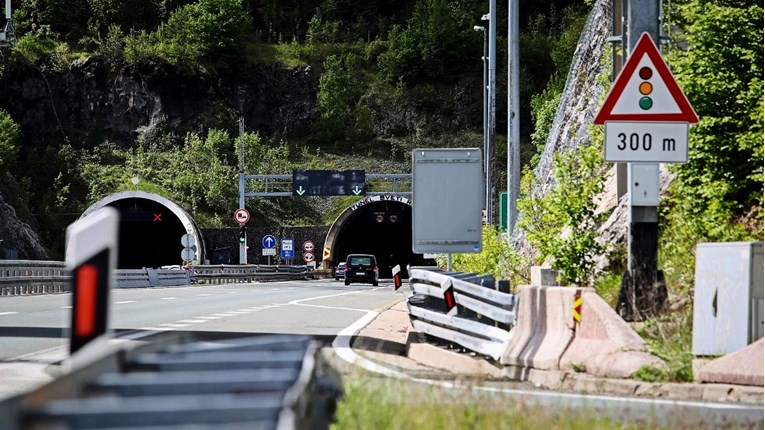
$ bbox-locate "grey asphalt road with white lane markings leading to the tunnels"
[0,280,403,399]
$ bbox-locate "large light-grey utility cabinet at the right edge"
[693,242,763,357]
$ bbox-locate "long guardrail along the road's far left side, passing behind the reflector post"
[0,260,314,296]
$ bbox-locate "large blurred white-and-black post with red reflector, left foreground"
[66,207,119,354]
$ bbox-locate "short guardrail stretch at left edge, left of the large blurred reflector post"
[0,260,71,296]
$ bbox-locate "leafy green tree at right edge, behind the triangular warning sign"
[670,0,763,240]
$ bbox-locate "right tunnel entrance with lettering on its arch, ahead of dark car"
[324,195,429,278]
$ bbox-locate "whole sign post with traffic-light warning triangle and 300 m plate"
[594,25,699,320]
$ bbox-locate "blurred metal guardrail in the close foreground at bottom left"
[0,333,341,430]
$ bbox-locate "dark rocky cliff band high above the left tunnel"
[0,58,319,146]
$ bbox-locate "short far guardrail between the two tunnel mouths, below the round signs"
[191,264,314,284]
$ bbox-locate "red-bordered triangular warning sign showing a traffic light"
[594,33,699,124]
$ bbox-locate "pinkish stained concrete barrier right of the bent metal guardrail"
[500,286,665,378]
